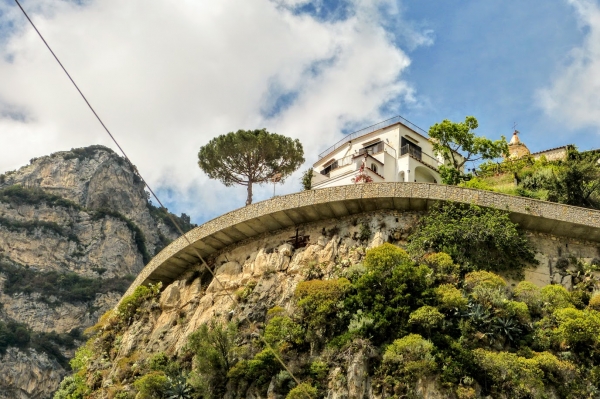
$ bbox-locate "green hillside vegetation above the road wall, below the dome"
[461,148,600,209]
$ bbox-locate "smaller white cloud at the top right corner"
[537,0,600,127]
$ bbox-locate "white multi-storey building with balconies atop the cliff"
[312,116,464,188]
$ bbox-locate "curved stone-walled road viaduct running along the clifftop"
[120,183,600,295]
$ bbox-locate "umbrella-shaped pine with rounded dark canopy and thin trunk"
[198,129,304,205]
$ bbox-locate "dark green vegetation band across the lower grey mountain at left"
[0,258,133,306]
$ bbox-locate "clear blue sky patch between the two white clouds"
[406,1,600,150]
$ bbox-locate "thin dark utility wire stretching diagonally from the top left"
[15,0,302,390]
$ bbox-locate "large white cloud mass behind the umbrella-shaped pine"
[0,0,429,219]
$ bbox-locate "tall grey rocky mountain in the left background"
[0,146,192,399]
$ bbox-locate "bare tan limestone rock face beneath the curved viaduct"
[75,212,440,399]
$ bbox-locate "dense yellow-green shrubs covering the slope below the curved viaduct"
[55,205,600,399]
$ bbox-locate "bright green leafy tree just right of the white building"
[429,116,508,184]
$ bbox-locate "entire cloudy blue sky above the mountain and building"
[0,0,600,223]
